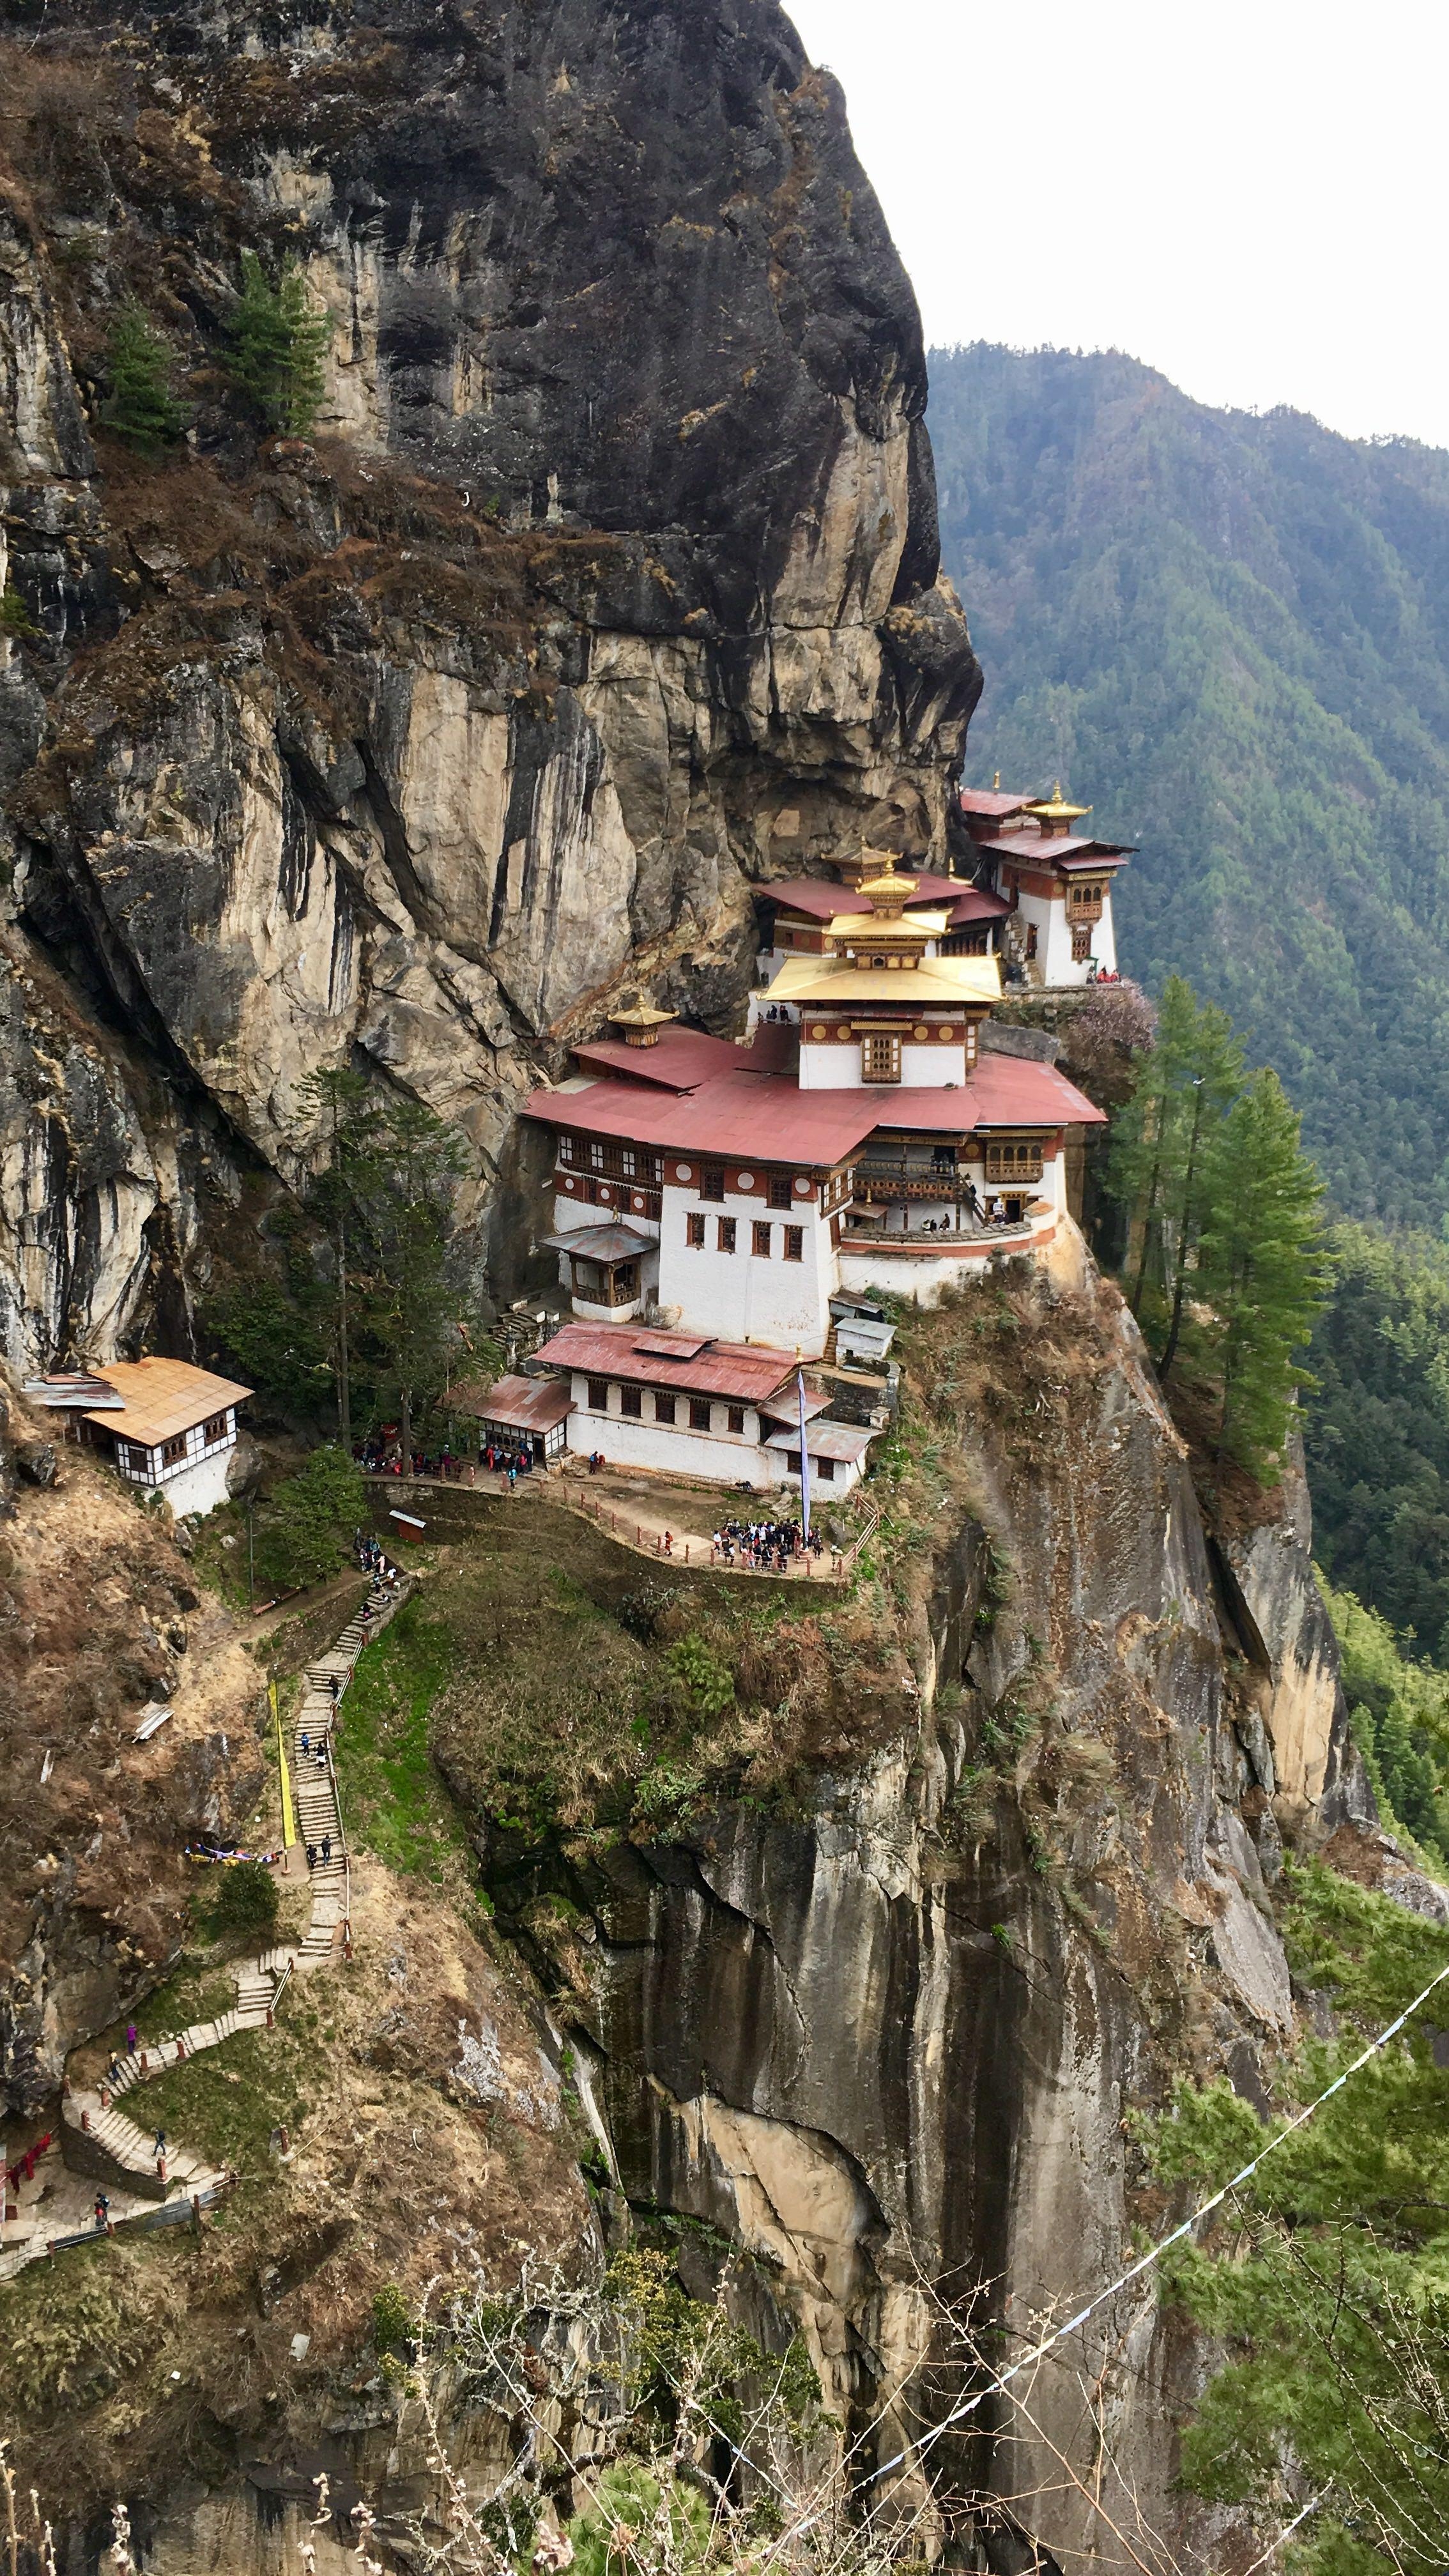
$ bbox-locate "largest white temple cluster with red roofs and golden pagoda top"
[480,853,1103,1492]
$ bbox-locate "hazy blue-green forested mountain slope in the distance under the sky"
[931,345,1449,1231]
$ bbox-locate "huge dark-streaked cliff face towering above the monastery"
[0,0,980,1363]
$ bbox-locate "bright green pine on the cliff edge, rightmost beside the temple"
[1199,1071,1330,1483]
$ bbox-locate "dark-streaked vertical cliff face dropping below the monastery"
[521,1288,1340,2568]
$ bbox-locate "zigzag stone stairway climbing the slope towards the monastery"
[0,1582,413,2280]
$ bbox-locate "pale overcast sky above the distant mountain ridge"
[786,0,1449,446]
